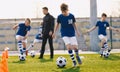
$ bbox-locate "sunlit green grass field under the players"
[3,54,120,72]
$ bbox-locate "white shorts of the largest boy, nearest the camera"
[62,36,78,45]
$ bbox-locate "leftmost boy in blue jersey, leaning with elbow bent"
[13,18,31,55]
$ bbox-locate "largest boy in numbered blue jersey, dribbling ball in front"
[53,3,82,67]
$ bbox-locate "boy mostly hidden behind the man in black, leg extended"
[27,26,42,51]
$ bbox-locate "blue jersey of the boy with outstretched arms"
[96,21,109,36]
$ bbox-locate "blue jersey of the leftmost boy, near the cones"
[16,23,31,36]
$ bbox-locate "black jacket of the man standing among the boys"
[42,13,55,35]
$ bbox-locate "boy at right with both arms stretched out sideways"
[87,13,119,56]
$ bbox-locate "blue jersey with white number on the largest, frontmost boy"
[57,13,76,37]
